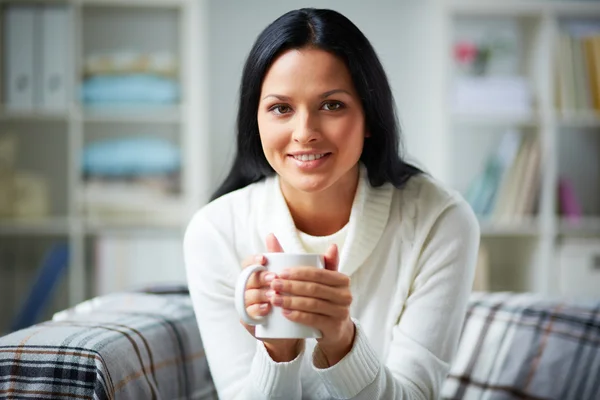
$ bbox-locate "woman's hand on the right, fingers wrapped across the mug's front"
[268,245,355,366]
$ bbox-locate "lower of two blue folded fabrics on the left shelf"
[83,137,181,176]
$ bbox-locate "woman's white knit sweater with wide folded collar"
[184,168,479,400]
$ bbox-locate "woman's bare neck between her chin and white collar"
[281,167,359,236]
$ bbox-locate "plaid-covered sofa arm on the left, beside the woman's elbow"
[0,293,217,399]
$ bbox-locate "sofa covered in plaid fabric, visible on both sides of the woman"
[0,288,600,400]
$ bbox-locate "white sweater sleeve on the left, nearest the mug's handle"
[183,211,304,400]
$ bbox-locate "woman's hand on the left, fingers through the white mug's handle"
[240,234,301,362]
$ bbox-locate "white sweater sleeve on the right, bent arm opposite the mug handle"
[313,202,479,400]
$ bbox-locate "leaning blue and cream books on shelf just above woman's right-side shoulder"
[465,130,541,222]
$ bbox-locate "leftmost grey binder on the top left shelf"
[4,5,39,111]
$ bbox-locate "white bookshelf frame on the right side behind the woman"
[439,0,600,296]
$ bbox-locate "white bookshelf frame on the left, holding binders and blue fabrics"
[0,0,210,324]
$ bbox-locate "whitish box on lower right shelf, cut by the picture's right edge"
[558,239,600,299]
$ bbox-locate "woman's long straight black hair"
[212,8,421,200]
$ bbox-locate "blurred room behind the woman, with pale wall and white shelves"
[0,0,600,333]
